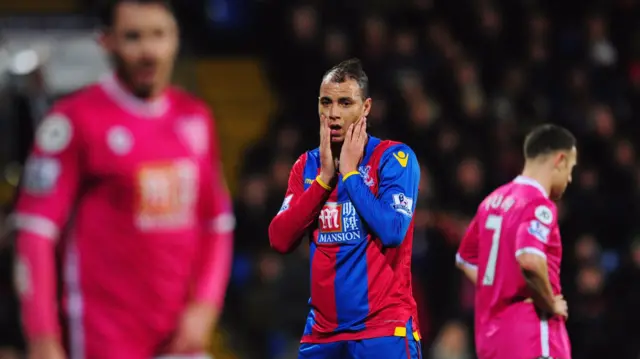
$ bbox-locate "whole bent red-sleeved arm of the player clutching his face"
[269,154,332,253]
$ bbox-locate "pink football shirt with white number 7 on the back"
[456,176,571,359]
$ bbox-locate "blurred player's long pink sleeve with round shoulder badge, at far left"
[12,111,81,338]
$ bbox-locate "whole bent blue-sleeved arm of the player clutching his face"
[343,145,420,247]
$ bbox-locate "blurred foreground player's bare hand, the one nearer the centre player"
[169,303,218,354]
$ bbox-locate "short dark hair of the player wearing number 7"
[524,124,576,159]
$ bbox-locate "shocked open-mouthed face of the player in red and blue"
[318,79,371,143]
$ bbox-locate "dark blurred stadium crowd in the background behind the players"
[0,0,640,359]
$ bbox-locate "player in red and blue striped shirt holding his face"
[269,60,420,359]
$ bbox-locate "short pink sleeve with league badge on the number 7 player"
[515,199,556,258]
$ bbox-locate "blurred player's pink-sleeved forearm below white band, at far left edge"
[15,232,60,340]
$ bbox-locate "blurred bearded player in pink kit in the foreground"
[14,0,233,359]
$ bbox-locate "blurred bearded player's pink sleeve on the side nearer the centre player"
[194,111,235,310]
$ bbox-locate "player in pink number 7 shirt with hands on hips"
[456,125,577,359]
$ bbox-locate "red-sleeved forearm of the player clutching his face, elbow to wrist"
[269,180,331,253]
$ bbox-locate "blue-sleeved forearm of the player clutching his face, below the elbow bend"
[343,174,411,247]
